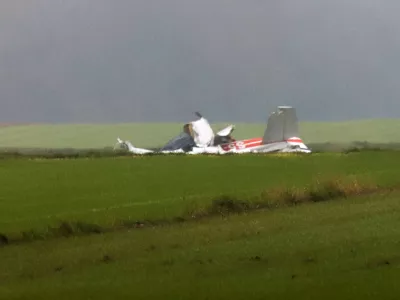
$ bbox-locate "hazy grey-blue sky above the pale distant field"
[0,0,400,122]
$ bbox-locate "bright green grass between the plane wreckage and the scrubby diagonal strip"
[0,151,400,234]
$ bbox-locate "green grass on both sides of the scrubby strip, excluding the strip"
[0,151,400,299]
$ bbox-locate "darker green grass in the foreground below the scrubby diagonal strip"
[0,194,400,299]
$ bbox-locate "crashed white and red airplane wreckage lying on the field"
[114,106,311,154]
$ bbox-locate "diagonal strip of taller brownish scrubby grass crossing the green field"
[0,178,382,246]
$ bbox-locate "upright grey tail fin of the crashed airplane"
[262,106,299,144]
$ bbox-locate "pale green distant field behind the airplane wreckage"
[0,119,400,148]
